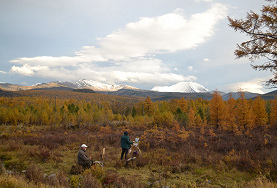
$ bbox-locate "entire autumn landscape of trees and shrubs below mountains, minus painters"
[0,91,277,187]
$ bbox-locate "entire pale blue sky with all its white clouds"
[0,0,276,93]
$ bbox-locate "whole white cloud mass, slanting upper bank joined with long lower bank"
[10,4,227,83]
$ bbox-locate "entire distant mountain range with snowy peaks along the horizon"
[0,79,277,100]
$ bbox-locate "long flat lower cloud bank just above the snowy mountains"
[12,60,196,84]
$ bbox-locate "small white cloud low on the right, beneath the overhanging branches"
[218,79,265,94]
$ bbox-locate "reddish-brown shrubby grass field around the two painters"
[0,125,277,187]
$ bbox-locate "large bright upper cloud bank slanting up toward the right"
[92,4,227,59]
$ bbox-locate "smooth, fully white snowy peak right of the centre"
[152,82,209,93]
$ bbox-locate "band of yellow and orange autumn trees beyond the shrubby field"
[0,91,277,133]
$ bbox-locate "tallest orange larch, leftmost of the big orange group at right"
[210,91,225,128]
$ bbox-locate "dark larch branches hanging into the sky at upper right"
[228,0,277,87]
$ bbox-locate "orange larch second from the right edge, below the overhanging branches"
[252,96,267,126]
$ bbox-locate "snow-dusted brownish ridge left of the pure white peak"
[58,80,138,91]
